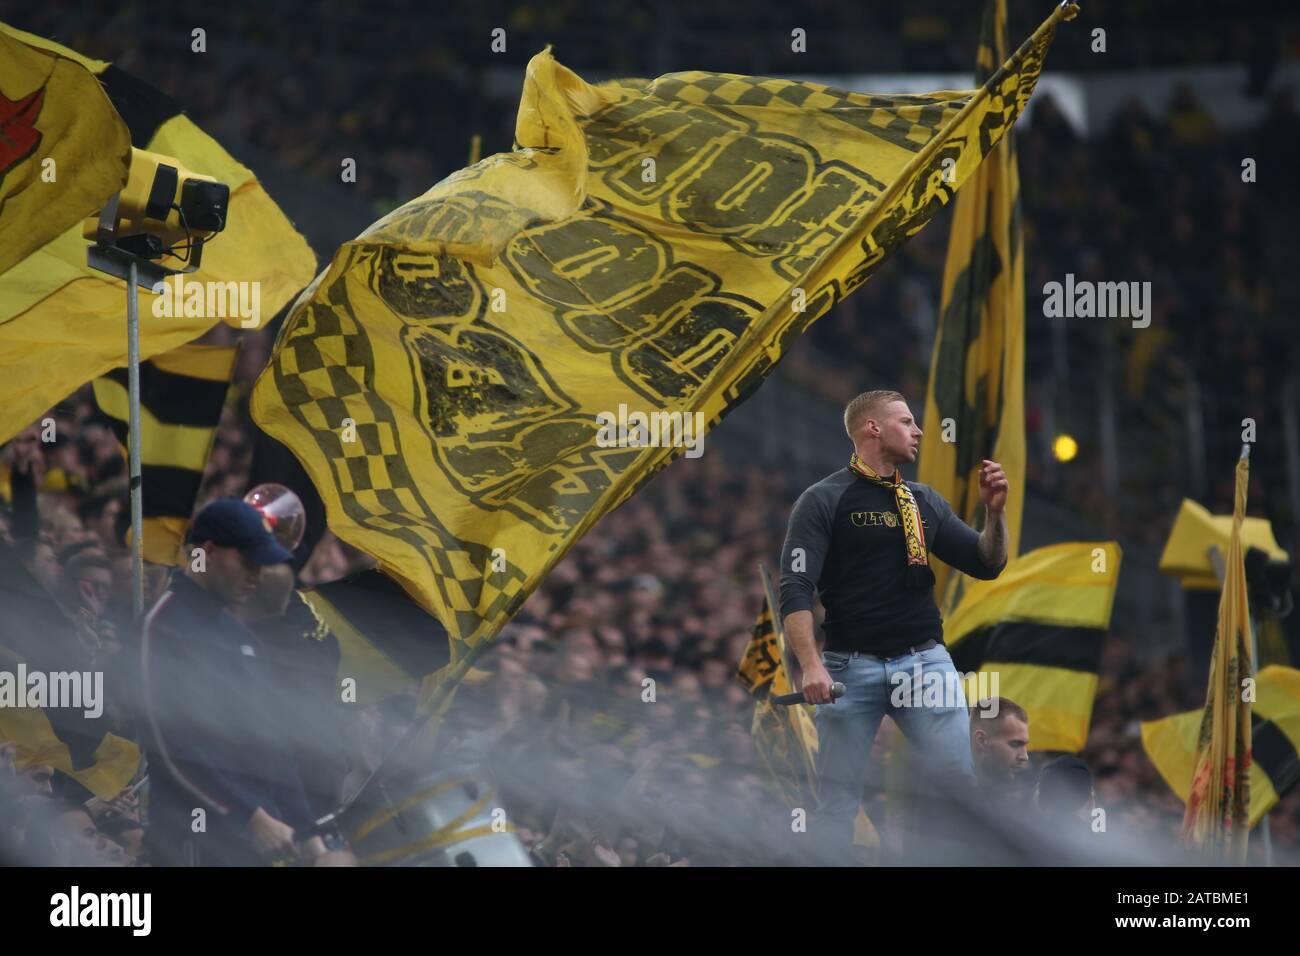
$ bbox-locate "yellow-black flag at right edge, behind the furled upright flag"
[1141,665,1300,827]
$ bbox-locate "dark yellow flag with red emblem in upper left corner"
[0,31,131,273]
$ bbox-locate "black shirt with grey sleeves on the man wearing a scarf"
[781,467,1002,657]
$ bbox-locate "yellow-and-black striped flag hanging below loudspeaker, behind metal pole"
[94,345,239,566]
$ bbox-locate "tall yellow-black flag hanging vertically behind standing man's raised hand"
[919,0,1026,613]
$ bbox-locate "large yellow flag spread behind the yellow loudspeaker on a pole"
[0,23,316,441]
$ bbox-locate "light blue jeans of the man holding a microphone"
[815,644,975,849]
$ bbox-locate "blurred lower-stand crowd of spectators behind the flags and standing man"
[0,403,1300,865]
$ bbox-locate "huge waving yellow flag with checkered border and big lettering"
[252,7,1074,641]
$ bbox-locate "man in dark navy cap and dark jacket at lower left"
[140,498,324,866]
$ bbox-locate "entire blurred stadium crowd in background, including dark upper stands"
[0,3,1300,866]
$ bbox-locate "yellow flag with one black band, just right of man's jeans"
[944,541,1121,753]
